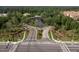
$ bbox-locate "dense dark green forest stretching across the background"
[0,6,79,41]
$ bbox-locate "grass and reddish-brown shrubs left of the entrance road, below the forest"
[0,27,29,42]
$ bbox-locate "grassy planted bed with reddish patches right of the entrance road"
[49,29,79,42]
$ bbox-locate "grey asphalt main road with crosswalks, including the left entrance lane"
[0,29,79,52]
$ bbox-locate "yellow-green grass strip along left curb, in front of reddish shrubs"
[0,32,24,42]
